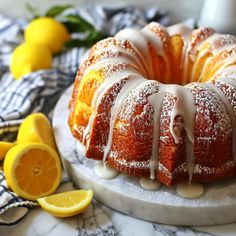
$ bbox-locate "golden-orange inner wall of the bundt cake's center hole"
[148,32,215,85]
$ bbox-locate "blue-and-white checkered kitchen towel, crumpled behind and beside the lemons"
[0,6,169,224]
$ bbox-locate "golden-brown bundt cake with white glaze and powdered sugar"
[68,22,236,185]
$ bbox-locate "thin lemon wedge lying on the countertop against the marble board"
[37,190,93,217]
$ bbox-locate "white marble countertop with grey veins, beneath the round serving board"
[0,182,236,236]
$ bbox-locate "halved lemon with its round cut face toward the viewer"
[3,143,61,200]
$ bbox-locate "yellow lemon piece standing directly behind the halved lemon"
[17,113,57,151]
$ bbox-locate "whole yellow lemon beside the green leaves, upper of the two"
[25,17,70,53]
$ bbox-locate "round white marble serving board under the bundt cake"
[53,85,236,226]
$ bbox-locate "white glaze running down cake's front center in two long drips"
[149,84,196,181]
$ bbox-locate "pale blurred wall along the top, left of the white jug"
[0,0,204,23]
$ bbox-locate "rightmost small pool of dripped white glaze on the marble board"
[176,182,204,198]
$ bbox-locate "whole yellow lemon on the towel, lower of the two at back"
[10,43,52,79]
